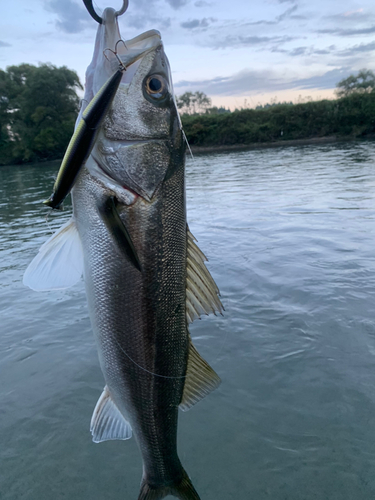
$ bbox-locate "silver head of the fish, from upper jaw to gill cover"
[87,10,185,202]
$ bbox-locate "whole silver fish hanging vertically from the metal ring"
[24,8,223,500]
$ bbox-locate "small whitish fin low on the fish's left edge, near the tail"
[90,386,132,443]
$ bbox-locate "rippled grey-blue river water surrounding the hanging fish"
[0,142,375,500]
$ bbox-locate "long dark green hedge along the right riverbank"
[182,92,375,146]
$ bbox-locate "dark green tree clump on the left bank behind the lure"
[0,64,82,165]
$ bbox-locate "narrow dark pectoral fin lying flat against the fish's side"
[98,196,142,271]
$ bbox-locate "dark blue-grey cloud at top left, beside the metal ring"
[45,0,91,33]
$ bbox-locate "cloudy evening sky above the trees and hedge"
[0,0,375,109]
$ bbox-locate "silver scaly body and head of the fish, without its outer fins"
[73,36,222,499]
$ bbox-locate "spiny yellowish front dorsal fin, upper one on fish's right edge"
[186,229,224,323]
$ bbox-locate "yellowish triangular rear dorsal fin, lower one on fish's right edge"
[180,339,221,411]
